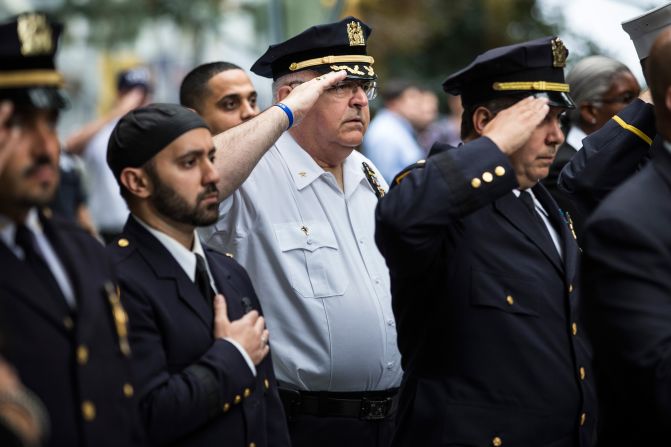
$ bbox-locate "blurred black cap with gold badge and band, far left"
[0,12,67,109]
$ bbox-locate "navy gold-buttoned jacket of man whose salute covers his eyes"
[376,138,596,447]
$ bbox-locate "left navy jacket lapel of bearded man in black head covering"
[124,220,214,328]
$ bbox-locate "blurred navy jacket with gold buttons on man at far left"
[0,211,139,447]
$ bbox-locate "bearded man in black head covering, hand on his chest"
[107,104,289,447]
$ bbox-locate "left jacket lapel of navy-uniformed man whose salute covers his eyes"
[494,189,564,275]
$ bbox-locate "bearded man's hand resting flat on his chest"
[214,294,270,365]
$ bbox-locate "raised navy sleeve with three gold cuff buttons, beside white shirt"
[375,137,517,275]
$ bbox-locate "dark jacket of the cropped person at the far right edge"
[583,136,671,446]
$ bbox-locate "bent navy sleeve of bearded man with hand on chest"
[121,281,255,444]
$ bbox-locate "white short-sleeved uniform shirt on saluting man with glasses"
[208,133,402,391]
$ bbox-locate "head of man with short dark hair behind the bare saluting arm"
[179,62,259,135]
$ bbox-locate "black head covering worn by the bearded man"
[107,104,209,182]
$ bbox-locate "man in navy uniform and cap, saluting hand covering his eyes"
[376,37,596,447]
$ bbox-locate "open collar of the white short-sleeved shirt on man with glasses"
[275,132,365,196]
